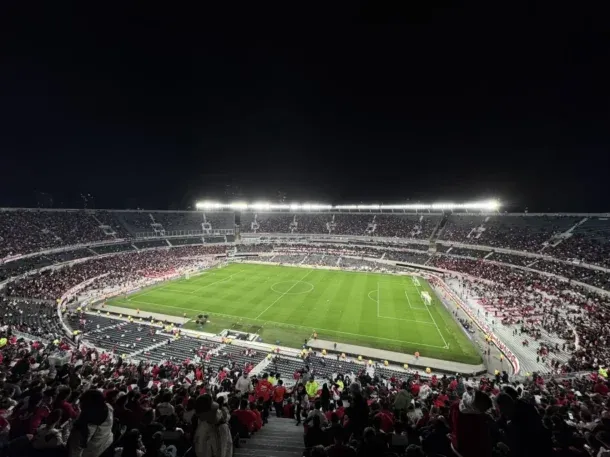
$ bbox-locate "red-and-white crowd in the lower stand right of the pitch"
[433,257,610,372]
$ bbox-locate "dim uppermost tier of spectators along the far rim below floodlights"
[0,210,610,274]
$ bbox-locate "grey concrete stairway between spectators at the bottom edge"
[233,412,305,457]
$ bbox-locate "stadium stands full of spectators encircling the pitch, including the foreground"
[0,209,610,457]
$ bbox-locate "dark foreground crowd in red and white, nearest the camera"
[0,327,610,457]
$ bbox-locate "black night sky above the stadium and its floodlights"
[0,2,610,211]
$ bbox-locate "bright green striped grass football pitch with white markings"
[108,263,481,364]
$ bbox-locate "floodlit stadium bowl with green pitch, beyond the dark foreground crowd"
[0,201,610,455]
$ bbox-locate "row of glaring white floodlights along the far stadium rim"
[195,200,501,211]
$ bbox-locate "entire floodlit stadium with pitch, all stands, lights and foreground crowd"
[0,205,610,457]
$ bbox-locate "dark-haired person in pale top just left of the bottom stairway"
[193,394,233,457]
